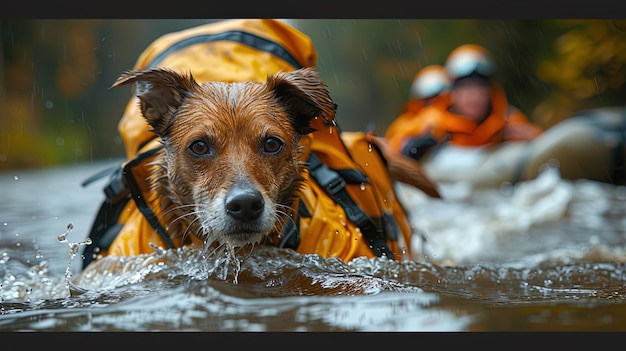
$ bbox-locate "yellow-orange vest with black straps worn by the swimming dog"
[83,19,412,267]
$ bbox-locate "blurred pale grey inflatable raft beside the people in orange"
[420,107,626,187]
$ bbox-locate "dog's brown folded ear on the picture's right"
[266,67,337,135]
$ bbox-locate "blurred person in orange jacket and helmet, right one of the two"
[385,44,543,160]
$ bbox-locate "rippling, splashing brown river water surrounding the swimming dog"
[0,163,626,331]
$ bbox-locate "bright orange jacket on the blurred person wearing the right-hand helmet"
[385,87,542,157]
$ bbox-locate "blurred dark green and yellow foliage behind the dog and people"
[0,19,626,170]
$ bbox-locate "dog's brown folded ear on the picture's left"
[112,68,198,136]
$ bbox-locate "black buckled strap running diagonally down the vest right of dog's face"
[309,152,394,259]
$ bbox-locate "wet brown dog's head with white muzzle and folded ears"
[113,68,335,247]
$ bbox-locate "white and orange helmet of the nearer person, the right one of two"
[445,44,496,80]
